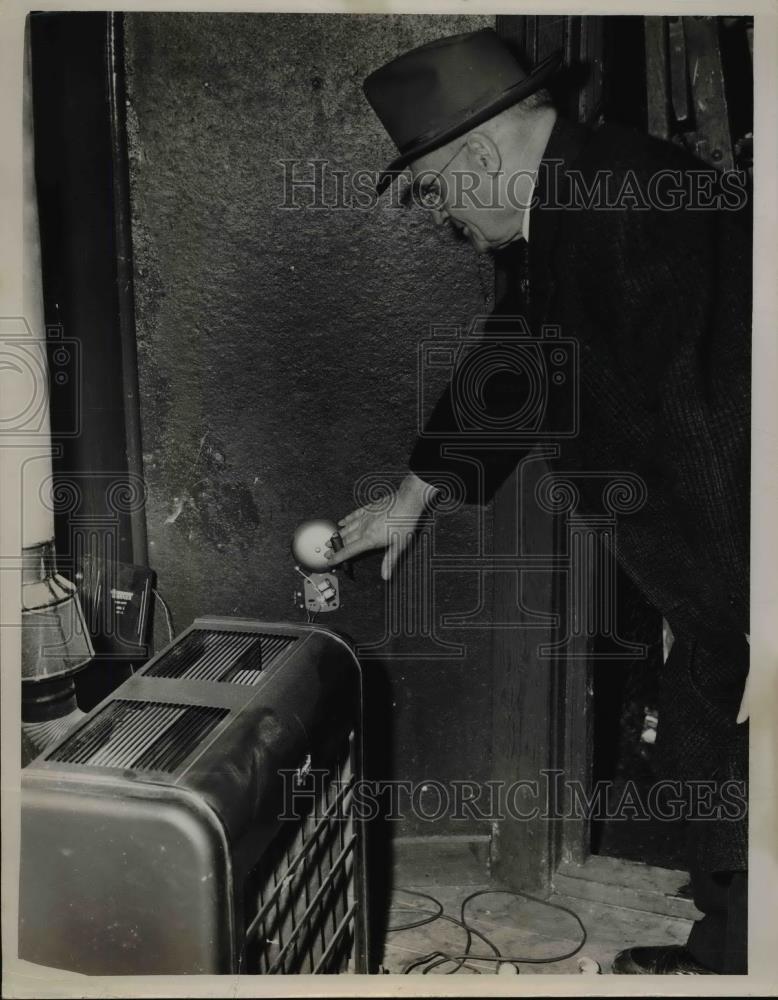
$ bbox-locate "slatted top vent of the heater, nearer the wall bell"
[146,629,297,684]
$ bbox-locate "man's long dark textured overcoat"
[410,119,752,870]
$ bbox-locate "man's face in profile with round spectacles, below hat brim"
[411,134,522,253]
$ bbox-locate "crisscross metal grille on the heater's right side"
[241,733,357,975]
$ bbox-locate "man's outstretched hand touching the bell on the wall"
[327,473,438,580]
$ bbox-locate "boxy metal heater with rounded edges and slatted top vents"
[19,618,368,975]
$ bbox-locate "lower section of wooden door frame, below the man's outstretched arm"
[491,453,592,890]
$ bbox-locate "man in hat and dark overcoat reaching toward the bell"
[324,30,751,974]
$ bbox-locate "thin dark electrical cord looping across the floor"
[389,889,587,975]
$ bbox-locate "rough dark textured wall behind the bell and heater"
[126,14,492,832]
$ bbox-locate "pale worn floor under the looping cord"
[383,885,691,975]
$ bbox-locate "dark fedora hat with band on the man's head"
[363,28,562,194]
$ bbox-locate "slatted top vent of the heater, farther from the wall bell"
[46,701,229,772]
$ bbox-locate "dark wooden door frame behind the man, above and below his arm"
[491,16,604,889]
